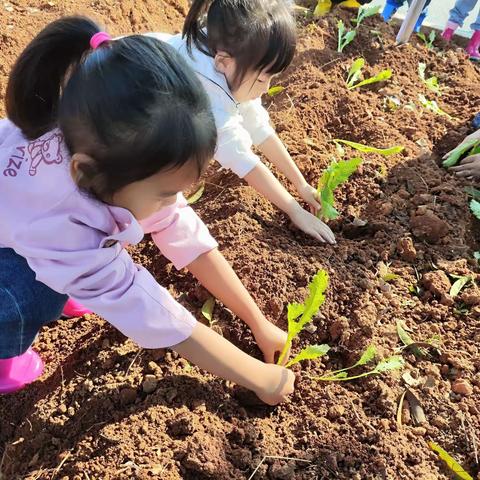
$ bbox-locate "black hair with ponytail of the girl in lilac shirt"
[6,16,216,198]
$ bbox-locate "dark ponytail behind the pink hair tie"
[6,17,100,139]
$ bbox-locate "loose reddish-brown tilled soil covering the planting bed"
[0,0,480,480]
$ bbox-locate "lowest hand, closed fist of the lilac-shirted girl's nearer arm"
[252,365,295,405]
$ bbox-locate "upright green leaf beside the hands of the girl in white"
[317,158,362,220]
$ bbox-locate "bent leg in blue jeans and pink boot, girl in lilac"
[0,248,68,394]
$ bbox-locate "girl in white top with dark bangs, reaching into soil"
[150,0,335,243]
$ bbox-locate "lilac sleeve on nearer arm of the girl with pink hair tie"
[17,215,196,348]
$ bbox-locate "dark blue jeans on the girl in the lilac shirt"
[0,248,68,358]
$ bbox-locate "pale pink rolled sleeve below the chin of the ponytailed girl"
[140,194,218,270]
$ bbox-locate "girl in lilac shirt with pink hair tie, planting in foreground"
[0,17,294,404]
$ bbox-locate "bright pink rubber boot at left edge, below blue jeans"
[0,348,43,395]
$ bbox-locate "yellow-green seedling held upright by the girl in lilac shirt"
[278,270,330,366]
